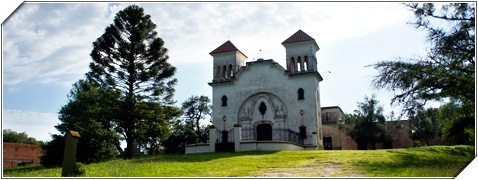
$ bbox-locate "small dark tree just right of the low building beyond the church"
[409,107,439,146]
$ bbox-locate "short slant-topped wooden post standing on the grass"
[61,131,80,177]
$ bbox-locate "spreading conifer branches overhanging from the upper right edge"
[372,3,476,113]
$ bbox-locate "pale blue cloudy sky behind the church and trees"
[2,2,434,141]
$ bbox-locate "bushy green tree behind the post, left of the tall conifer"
[42,80,122,166]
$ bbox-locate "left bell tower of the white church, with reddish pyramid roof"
[209,40,247,82]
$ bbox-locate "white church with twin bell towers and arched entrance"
[186,30,324,154]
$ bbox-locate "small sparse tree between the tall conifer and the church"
[182,96,212,143]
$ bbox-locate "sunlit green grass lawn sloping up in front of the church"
[3,146,475,177]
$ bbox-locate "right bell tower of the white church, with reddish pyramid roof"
[282,29,320,74]
